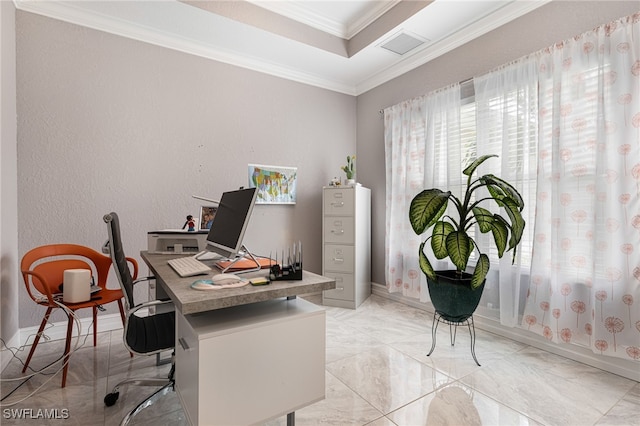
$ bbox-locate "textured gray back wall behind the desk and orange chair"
[16,11,356,327]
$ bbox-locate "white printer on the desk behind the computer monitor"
[147,229,209,254]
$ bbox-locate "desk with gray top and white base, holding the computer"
[141,252,335,425]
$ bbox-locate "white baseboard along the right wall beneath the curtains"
[371,283,640,382]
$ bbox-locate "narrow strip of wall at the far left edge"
[0,1,19,370]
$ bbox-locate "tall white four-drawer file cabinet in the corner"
[322,185,371,309]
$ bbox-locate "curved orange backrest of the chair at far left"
[20,244,111,301]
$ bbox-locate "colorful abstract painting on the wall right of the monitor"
[249,164,298,204]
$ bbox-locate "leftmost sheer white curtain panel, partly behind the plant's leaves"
[384,84,460,301]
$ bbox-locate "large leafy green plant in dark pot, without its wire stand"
[409,155,525,322]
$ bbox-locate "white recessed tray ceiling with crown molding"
[14,0,550,95]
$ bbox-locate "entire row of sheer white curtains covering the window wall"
[384,14,640,360]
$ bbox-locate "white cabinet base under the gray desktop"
[176,299,326,425]
